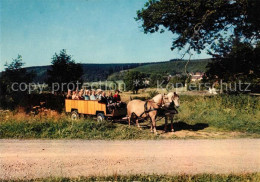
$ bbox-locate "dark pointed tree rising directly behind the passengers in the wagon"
[47,49,83,92]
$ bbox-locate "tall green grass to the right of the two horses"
[177,95,260,133]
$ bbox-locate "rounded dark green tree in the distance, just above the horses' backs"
[124,71,146,94]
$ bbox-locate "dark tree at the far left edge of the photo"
[0,55,35,109]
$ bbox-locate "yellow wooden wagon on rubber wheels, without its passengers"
[65,99,126,122]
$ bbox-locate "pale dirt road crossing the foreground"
[0,139,260,179]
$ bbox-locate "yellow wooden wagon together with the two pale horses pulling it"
[65,92,179,133]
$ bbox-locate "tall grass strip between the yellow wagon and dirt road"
[0,116,158,140]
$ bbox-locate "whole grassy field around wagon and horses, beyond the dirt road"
[0,94,260,140]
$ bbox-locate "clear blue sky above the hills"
[0,0,209,71]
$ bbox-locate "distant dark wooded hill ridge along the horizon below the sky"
[21,59,210,83]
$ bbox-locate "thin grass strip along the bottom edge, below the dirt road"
[3,173,260,182]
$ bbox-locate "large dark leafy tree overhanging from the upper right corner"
[136,0,260,92]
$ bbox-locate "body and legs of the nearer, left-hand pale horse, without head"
[127,100,159,134]
